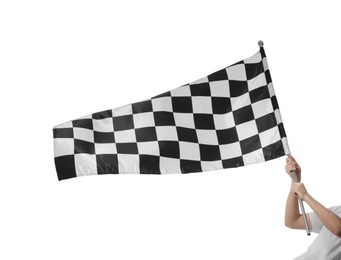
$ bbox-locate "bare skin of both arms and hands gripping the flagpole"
[285,156,341,237]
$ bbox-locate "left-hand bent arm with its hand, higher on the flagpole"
[284,156,311,230]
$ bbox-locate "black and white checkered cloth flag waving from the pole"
[53,47,289,180]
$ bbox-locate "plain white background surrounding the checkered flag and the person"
[0,0,341,260]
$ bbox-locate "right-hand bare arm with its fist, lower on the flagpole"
[293,183,341,237]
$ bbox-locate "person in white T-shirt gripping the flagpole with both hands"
[285,156,341,260]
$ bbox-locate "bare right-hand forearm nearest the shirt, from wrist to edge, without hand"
[303,194,341,237]
